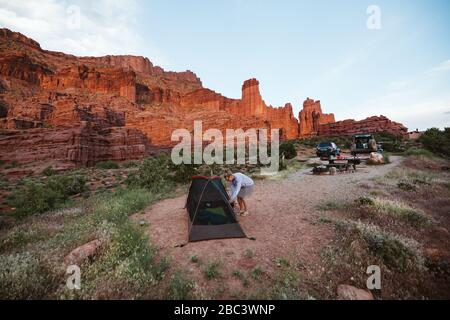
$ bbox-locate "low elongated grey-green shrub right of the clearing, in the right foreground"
[336,221,424,272]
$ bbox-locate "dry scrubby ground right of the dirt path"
[318,148,450,299]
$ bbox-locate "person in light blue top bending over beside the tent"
[225,171,255,217]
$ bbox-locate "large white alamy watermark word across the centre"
[171,121,280,175]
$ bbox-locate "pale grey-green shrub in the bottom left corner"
[0,252,58,300]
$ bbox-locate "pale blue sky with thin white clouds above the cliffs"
[0,0,450,130]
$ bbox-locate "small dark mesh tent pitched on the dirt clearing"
[186,176,247,242]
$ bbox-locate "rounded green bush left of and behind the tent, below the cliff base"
[125,155,171,192]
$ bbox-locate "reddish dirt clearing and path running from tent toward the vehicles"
[135,157,400,298]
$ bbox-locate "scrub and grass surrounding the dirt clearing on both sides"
[0,133,450,299]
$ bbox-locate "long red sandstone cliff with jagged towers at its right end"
[0,29,405,167]
